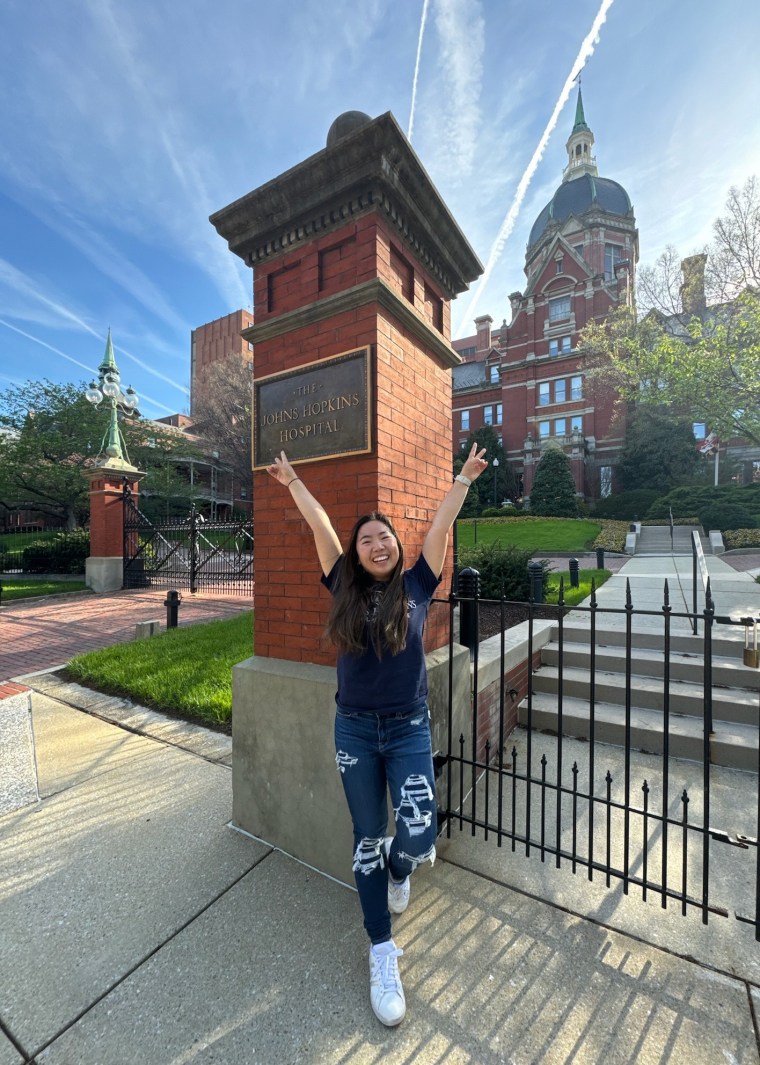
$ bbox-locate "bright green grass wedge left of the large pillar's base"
[66,610,253,730]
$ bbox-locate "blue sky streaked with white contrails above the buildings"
[0,0,760,417]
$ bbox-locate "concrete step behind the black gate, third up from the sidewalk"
[541,639,760,691]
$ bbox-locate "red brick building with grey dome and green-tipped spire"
[453,88,639,498]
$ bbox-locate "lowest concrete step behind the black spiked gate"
[517,693,758,771]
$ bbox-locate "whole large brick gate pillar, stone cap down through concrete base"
[211,112,482,878]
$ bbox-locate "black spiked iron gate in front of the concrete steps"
[439,581,760,940]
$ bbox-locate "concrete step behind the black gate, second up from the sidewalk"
[533,663,758,730]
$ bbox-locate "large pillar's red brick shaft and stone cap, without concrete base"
[211,113,482,663]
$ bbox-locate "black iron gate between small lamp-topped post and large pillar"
[122,485,253,596]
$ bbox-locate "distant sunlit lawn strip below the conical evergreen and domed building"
[457,518,601,552]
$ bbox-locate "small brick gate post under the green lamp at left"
[85,464,143,592]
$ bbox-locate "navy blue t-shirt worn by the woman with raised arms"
[321,555,441,714]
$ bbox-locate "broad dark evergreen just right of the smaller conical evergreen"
[617,406,700,492]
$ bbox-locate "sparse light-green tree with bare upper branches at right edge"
[578,177,760,444]
